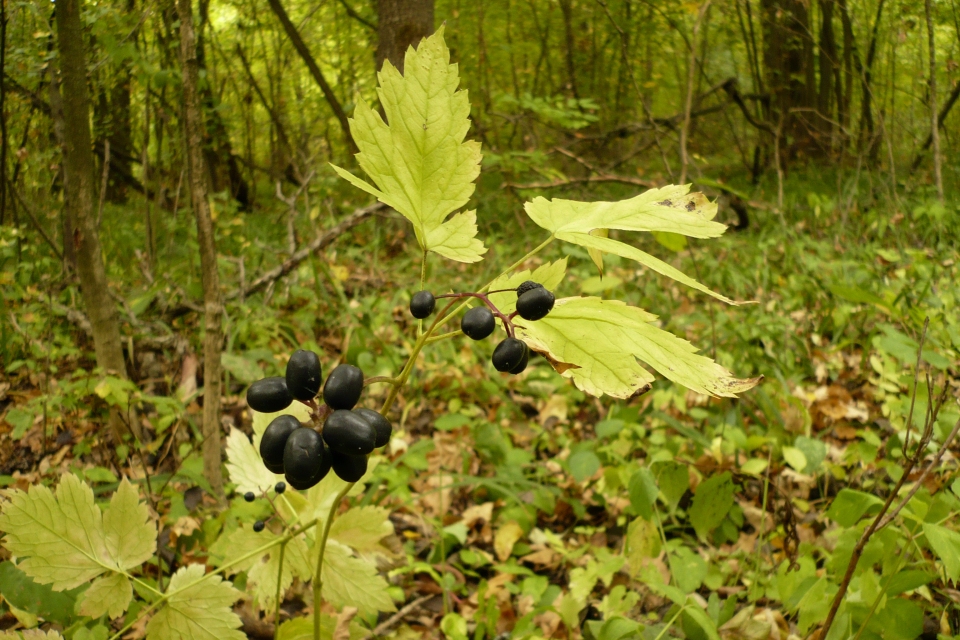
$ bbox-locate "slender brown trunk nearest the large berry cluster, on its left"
[177,0,223,498]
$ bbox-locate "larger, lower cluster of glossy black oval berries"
[244,349,393,492]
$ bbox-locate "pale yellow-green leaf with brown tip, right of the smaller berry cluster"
[515,298,760,398]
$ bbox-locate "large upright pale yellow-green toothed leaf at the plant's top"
[334,27,486,262]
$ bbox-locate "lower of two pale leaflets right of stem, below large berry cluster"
[322,540,396,615]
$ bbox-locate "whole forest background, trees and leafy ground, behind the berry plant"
[0,0,960,640]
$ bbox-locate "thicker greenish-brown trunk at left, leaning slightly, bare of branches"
[56,0,140,440]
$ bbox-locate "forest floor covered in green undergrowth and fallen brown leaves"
[0,181,960,640]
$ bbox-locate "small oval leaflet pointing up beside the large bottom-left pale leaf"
[104,478,157,568]
